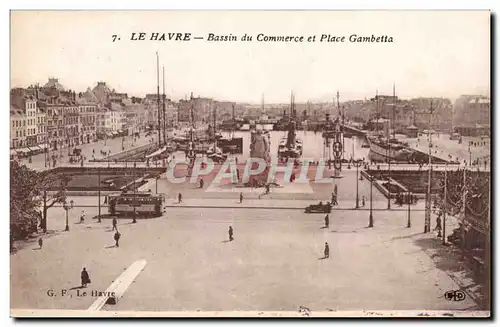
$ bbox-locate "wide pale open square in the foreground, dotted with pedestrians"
[11,200,475,311]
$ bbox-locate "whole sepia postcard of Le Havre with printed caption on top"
[9,11,493,317]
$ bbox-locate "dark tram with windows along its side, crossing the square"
[108,192,165,217]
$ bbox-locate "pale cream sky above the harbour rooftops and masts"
[10,11,490,103]
